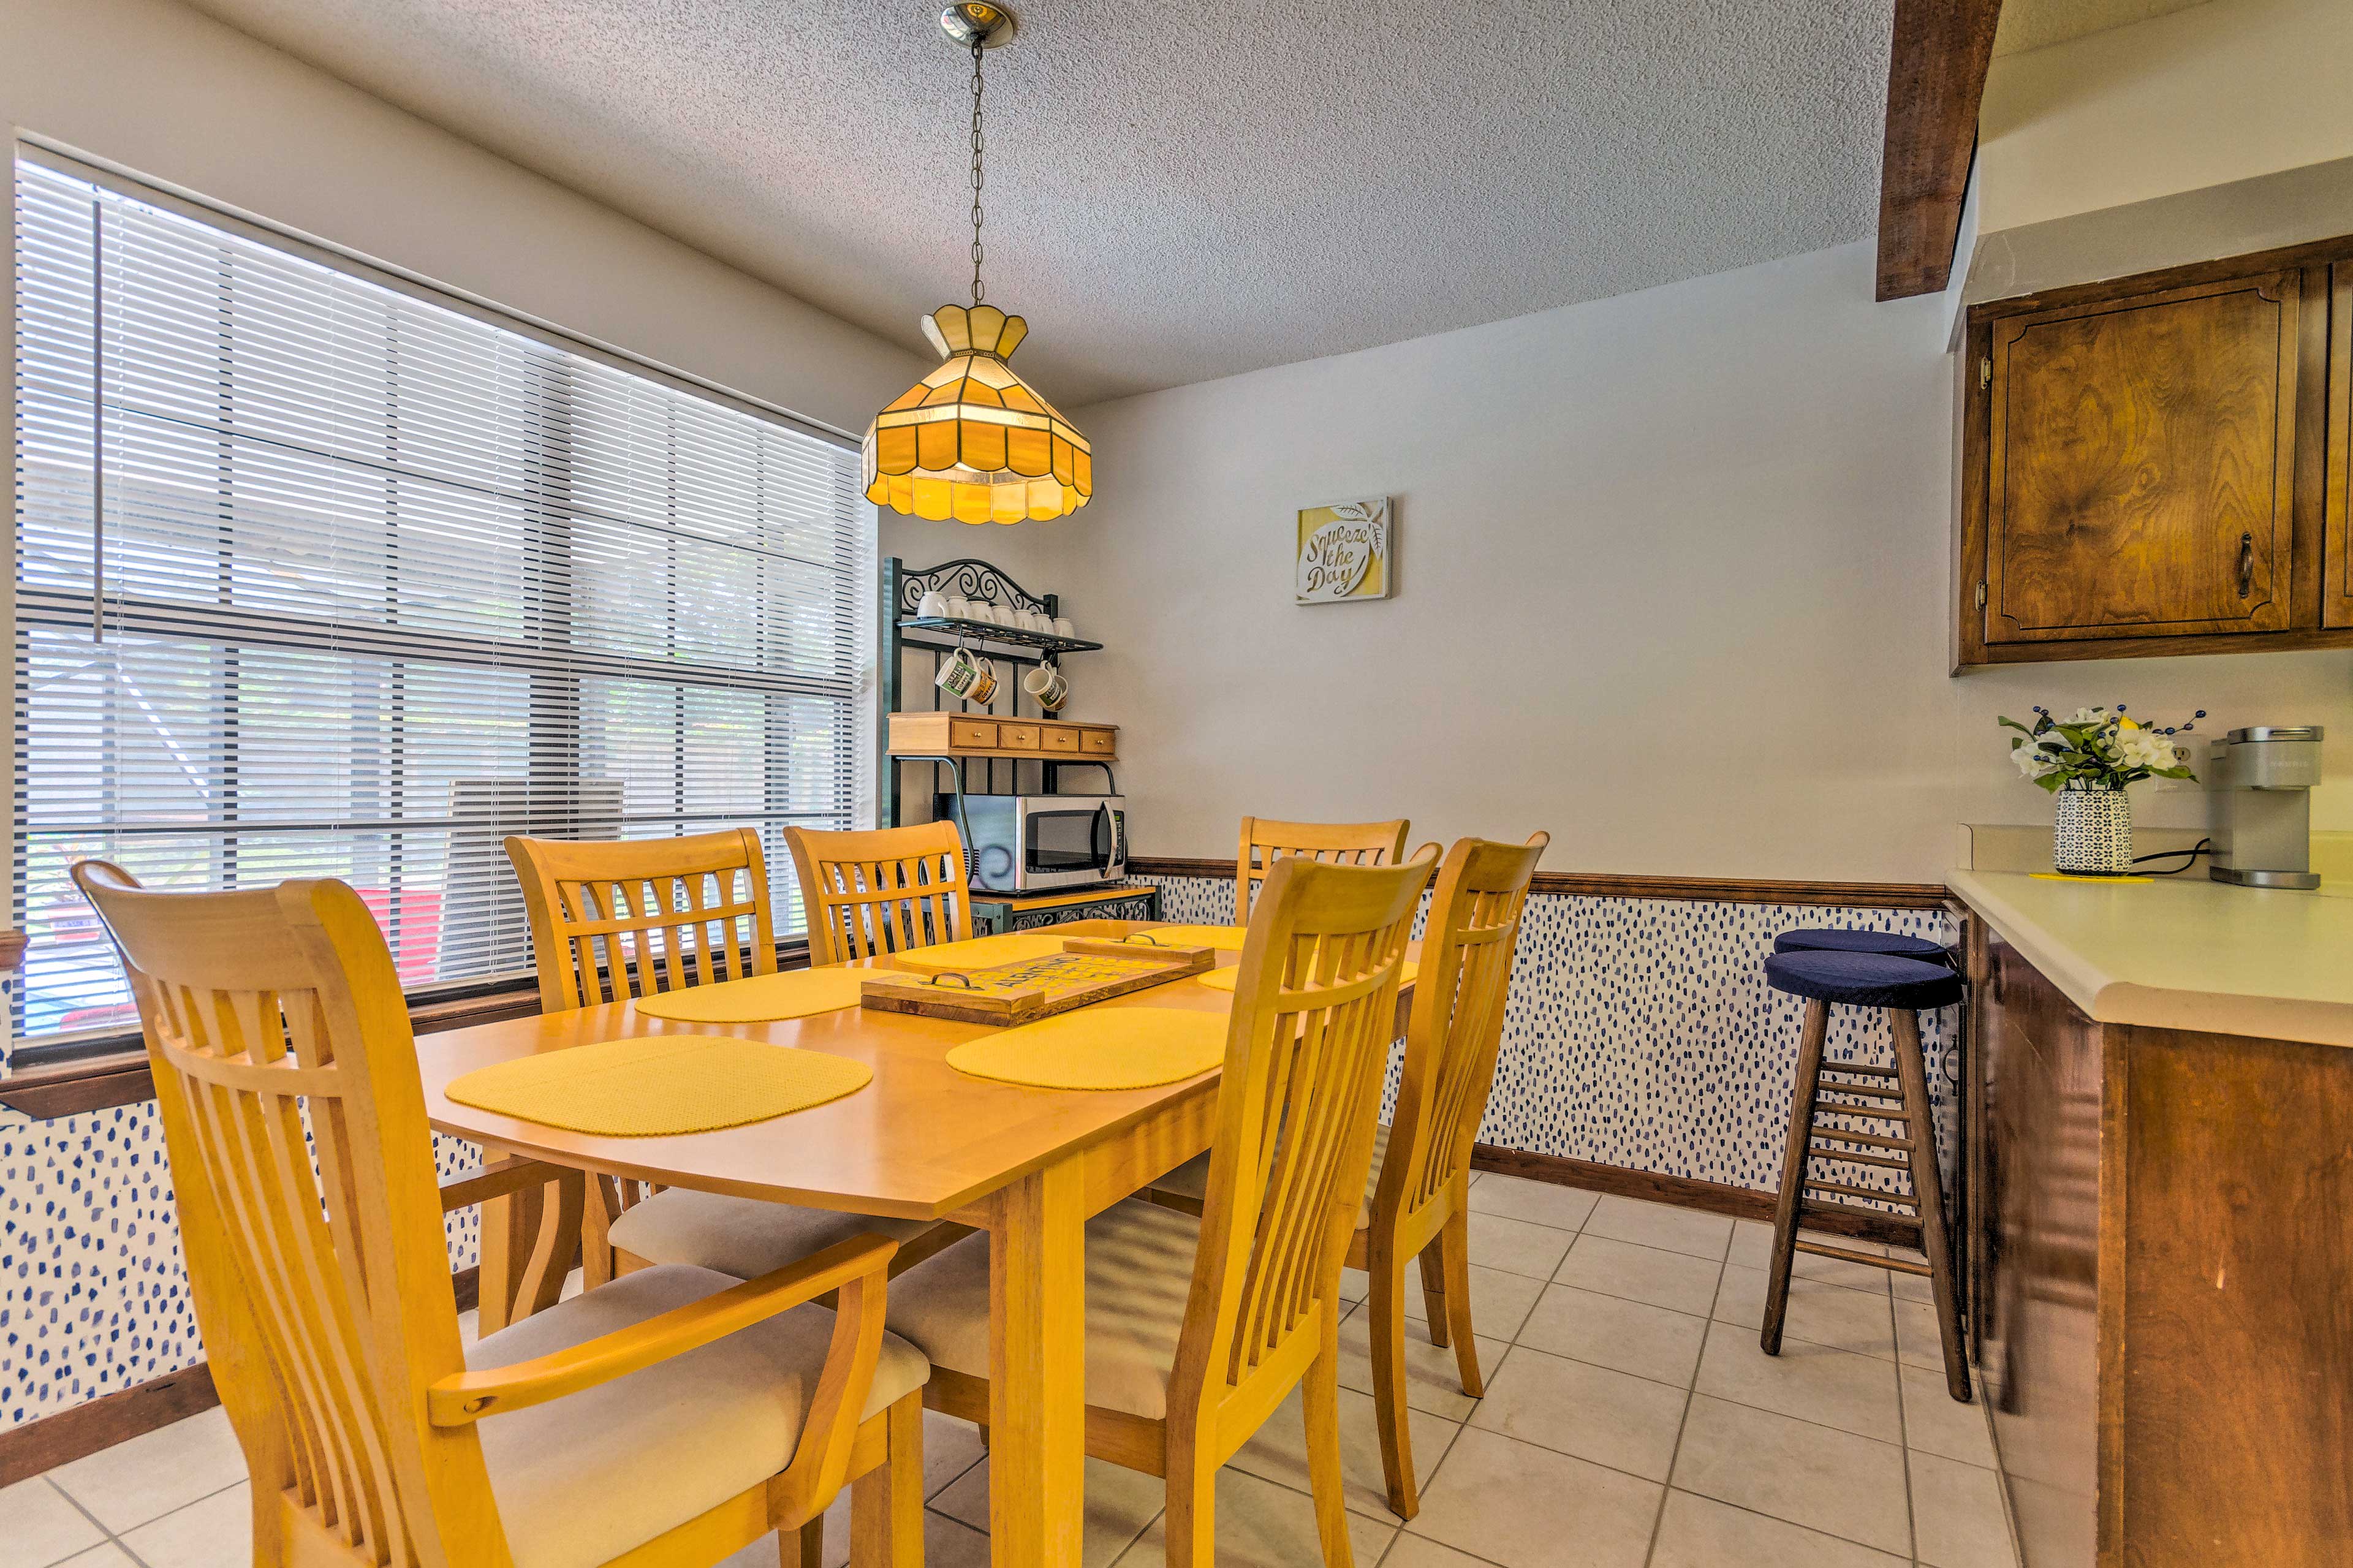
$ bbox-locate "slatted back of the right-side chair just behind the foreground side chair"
[1374,833,1553,1222]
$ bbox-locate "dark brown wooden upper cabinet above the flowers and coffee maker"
[1955,238,2353,666]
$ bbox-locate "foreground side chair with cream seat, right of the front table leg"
[892,859,1433,1568]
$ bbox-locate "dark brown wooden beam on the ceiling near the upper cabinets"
[1880,0,2003,299]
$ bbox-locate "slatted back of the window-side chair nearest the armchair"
[506,829,776,1012]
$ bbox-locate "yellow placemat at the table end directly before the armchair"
[442,1034,875,1137]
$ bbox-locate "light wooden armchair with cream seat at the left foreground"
[73,862,927,1568]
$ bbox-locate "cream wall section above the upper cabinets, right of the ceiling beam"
[1977,0,2353,233]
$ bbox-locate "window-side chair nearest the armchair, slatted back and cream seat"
[506,829,964,1286]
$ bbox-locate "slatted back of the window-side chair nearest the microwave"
[784,822,972,963]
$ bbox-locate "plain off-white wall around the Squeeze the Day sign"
[1054,245,2353,881]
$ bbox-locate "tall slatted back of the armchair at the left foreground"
[73,862,491,1568]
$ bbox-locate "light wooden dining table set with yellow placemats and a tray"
[417,920,1409,1568]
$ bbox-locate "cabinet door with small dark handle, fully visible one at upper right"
[1986,273,2299,643]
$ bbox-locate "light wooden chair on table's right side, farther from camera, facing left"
[1153,833,1553,1518]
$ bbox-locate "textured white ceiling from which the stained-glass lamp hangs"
[195,0,1901,407]
